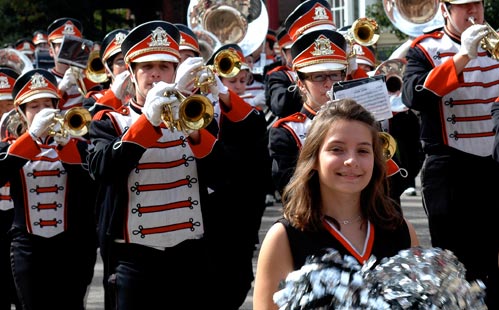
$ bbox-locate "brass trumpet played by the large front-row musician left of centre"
[161,91,214,132]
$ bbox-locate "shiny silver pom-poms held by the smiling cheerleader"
[274,247,487,310]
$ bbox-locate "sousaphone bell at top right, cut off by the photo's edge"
[383,0,444,38]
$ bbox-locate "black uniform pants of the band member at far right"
[421,151,499,309]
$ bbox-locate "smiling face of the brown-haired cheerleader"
[317,120,374,196]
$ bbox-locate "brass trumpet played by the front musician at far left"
[48,107,92,138]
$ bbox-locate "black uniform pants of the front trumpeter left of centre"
[113,239,211,310]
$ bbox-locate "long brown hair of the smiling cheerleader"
[282,99,403,231]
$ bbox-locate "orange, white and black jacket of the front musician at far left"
[0,133,95,238]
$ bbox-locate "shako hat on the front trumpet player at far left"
[12,69,61,108]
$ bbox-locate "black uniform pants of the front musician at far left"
[11,232,97,310]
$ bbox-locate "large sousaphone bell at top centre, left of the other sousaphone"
[187,0,269,55]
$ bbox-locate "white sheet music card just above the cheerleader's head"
[333,75,393,121]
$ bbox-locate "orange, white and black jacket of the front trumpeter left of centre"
[90,103,223,248]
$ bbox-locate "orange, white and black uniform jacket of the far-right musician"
[402,30,499,156]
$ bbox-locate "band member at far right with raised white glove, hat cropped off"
[402,0,499,309]
